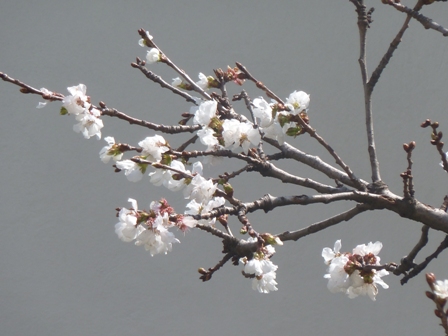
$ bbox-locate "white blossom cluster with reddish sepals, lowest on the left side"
[115,198,194,256]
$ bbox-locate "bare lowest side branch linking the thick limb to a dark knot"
[276,204,374,241]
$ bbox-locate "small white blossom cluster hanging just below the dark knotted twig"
[239,237,283,293]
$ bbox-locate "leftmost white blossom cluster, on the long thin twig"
[37,84,104,139]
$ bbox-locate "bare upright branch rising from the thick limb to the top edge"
[350,0,381,183]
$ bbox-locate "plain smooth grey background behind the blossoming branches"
[0,0,448,336]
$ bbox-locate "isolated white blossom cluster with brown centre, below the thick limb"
[322,240,389,301]
